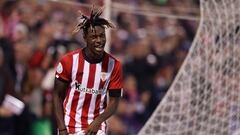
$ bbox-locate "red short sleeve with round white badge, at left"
[55,55,71,82]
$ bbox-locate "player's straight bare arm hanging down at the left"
[53,78,68,135]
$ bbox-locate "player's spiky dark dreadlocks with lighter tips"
[73,6,115,33]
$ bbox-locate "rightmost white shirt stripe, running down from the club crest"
[100,58,115,130]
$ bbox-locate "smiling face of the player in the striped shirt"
[84,26,106,56]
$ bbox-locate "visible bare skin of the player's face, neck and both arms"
[53,26,119,135]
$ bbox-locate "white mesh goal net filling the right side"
[139,0,240,135]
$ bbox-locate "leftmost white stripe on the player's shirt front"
[64,54,79,129]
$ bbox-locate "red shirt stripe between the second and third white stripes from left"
[81,64,96,130]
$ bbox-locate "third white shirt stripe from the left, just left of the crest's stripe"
[88,63,102,124]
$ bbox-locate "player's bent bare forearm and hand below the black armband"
[86,97,120,135]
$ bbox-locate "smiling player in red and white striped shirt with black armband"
[53,7,122,135]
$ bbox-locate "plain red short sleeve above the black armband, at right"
[108,61,123,90]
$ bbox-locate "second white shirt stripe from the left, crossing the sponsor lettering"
[75,60,90,131]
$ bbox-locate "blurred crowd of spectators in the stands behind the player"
[0,0,199,135]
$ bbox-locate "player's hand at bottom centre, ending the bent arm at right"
[85,119,102,135]
